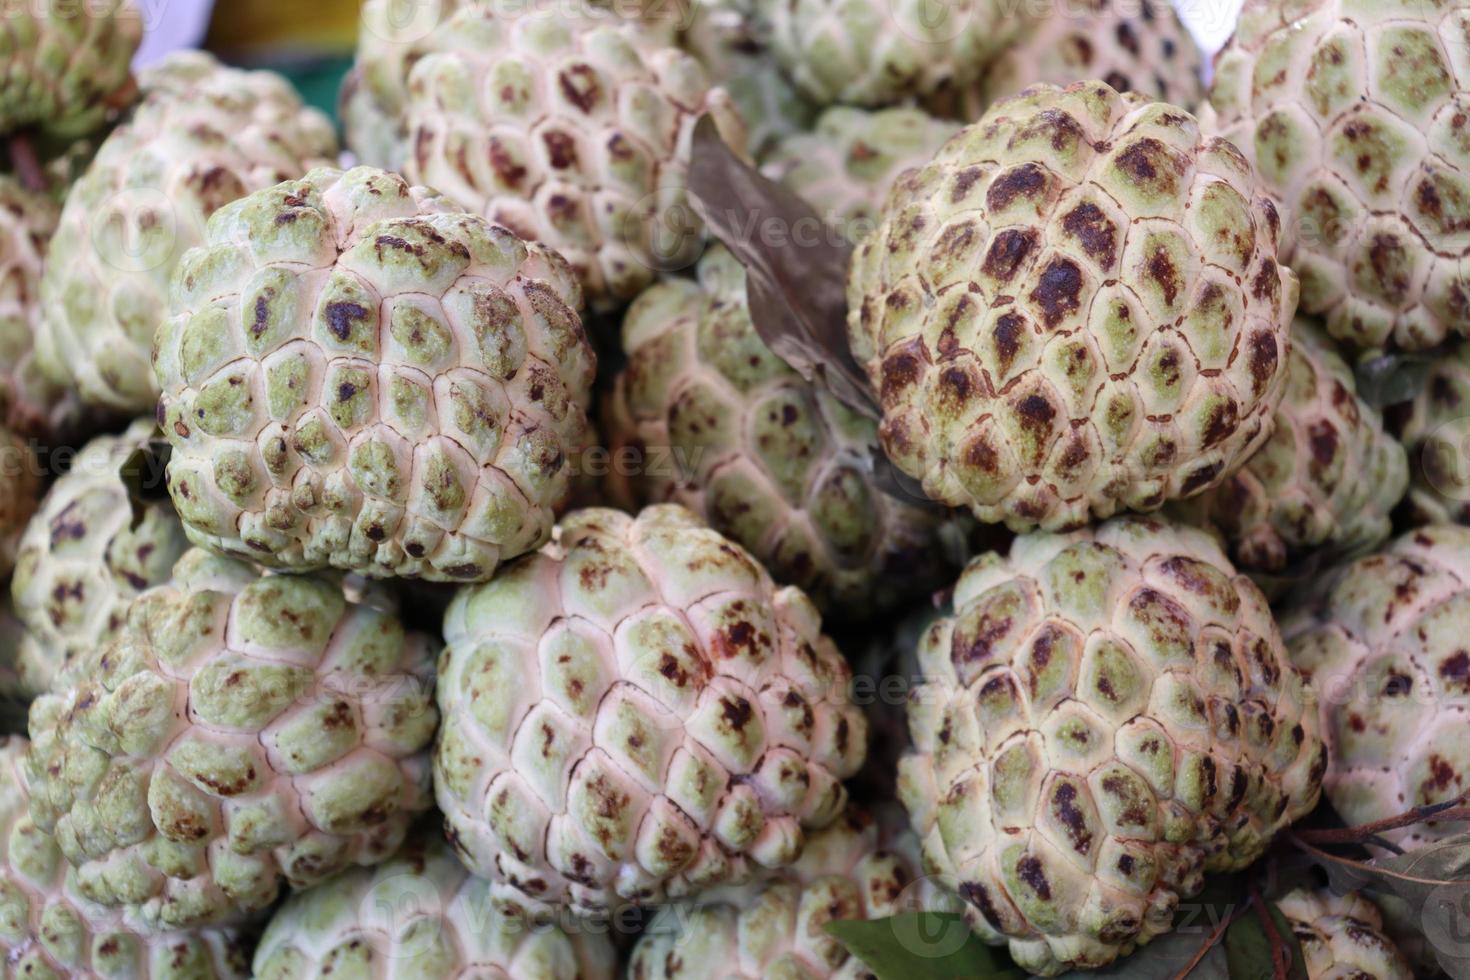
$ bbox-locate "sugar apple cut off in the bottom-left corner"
[0,738,250,980]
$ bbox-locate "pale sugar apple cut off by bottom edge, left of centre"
[254,830,617,980]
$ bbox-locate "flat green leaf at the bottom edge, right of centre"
[826,912,1026,980]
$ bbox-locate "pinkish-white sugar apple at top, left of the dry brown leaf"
[404,7,744,307]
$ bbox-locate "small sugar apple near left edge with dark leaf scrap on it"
[10,419,188,696]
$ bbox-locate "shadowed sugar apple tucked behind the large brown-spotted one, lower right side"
[1175,317,1408,573]
